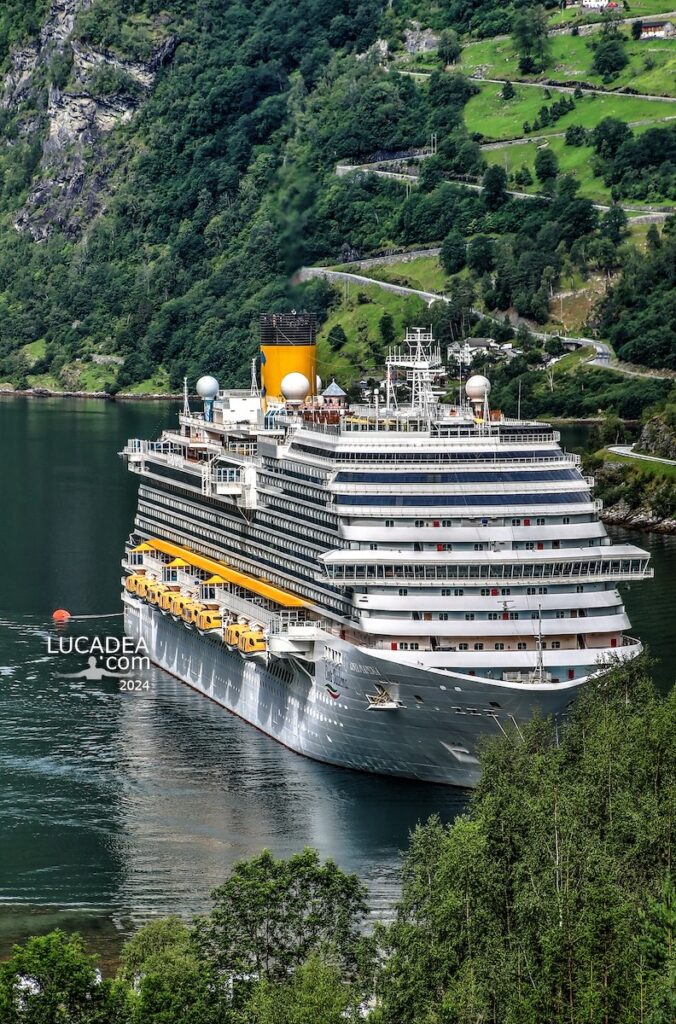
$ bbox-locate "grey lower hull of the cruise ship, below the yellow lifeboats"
[123,594,580,786]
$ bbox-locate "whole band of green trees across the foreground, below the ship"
[0,656,676,1024]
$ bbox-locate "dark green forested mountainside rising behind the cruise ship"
[0,0,676,390]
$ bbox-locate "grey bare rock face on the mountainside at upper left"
[0,0,178,241]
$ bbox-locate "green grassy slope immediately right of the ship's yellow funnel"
[316,282,425,387]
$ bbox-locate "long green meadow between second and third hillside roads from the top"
[465,82,676,141]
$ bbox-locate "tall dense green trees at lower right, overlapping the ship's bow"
[379,662,676,1024]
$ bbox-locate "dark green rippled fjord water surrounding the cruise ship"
[0,398,676,953]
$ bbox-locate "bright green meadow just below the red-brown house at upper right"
[461,35,676,96]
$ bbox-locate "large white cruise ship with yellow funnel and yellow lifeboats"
[122,312,651,786]
